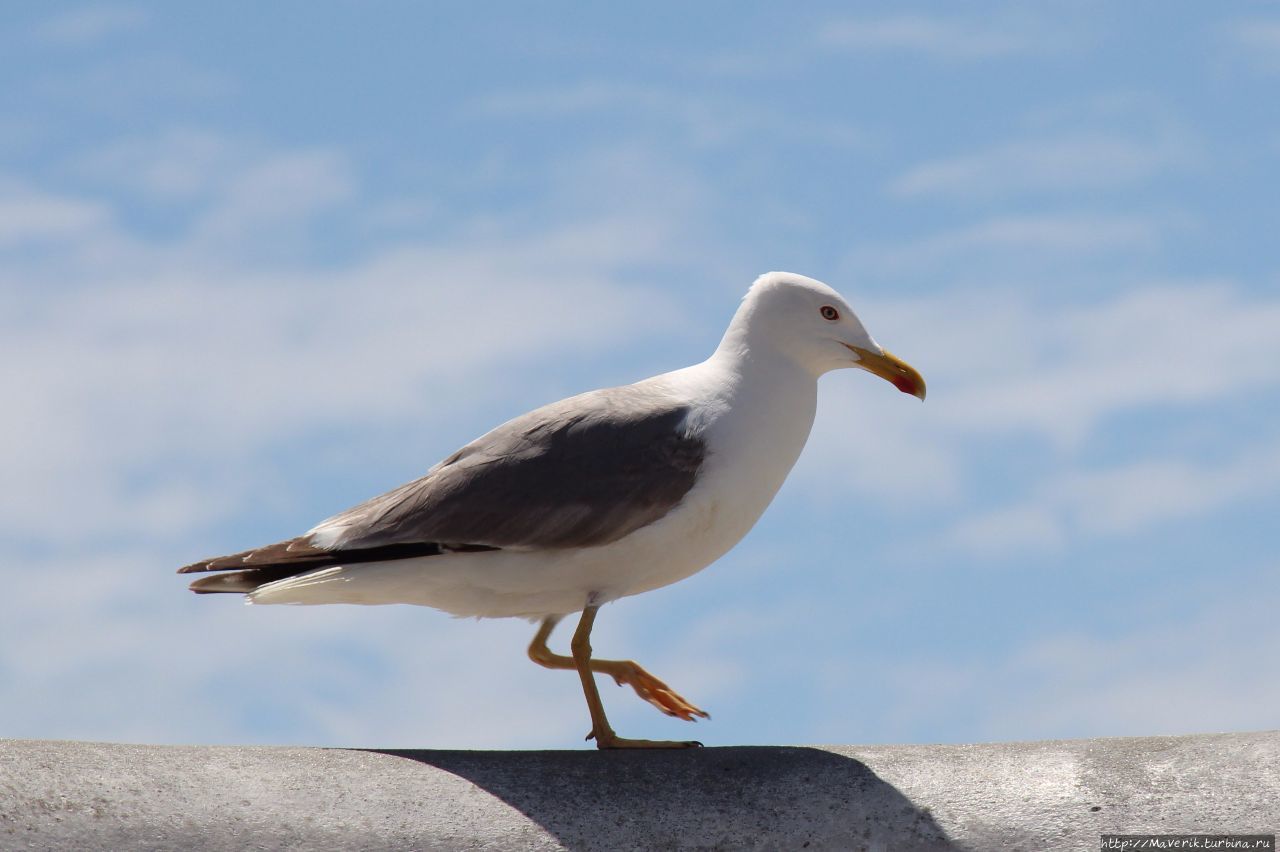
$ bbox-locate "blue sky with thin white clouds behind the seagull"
[0,3,1280,747]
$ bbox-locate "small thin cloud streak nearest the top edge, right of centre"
[818,15,1051,60]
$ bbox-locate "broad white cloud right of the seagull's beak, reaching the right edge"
[938,284,1280,444]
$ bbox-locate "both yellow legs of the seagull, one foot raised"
[529,605,707,748]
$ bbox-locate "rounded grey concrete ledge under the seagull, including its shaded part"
[0,732,1280,852]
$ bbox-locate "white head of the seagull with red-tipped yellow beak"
[726,272,925,399]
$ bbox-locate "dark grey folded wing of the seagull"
[303,385,707,551]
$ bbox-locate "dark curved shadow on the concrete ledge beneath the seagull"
[376,746,963,851]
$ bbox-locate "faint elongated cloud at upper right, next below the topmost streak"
[888,133,1192,198]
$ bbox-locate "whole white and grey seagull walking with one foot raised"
[179,272,925,748]
